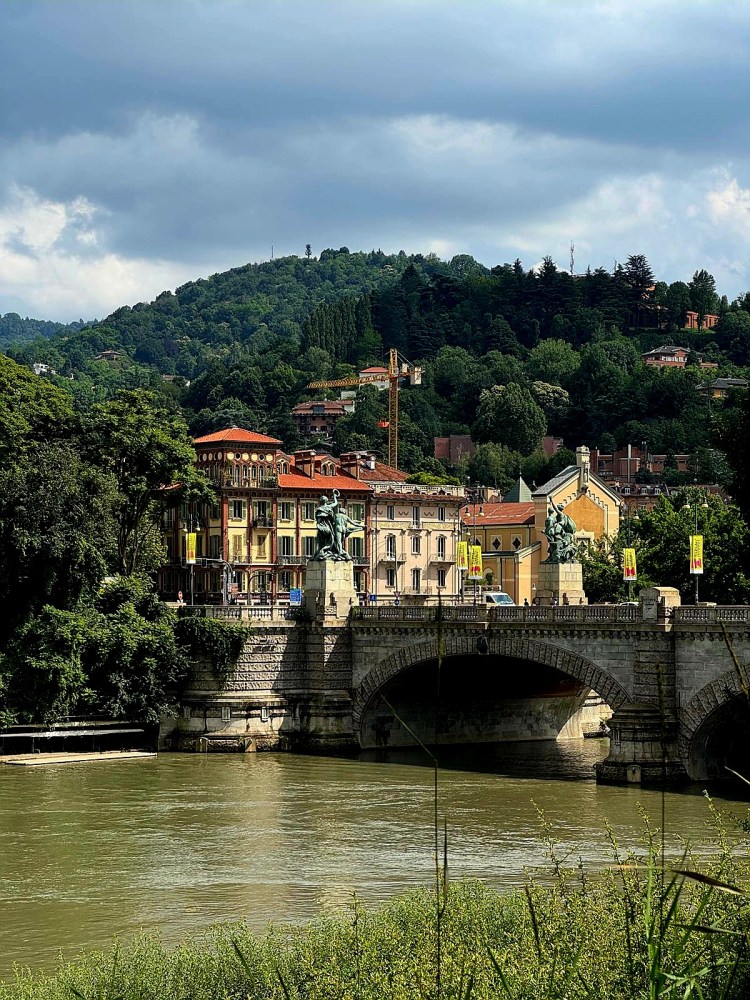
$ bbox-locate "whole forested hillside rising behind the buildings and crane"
[8,248,750,488]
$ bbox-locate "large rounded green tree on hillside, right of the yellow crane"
[474,382,547,455]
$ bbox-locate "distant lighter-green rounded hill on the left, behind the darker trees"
[14,247,452,379]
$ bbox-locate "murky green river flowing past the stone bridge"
[0,740,747,978]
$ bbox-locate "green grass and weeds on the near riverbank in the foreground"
[0,838,750,1000]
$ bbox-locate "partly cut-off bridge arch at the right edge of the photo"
[679,669,750,780]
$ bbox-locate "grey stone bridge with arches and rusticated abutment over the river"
[165,588,750,783]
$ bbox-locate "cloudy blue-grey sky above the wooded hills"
[0,0,750,320]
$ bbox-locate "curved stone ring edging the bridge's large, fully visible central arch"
[352,632,631,734]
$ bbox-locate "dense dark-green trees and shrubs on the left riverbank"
[0,355,223,724]
